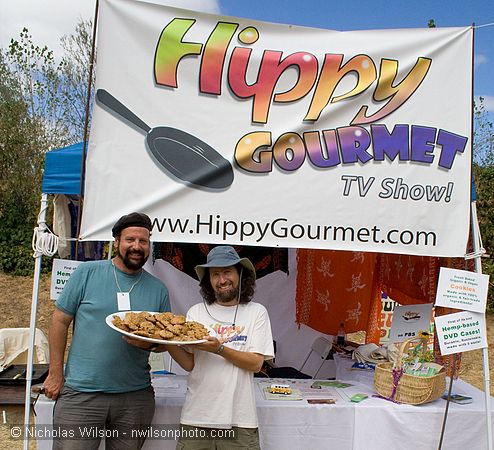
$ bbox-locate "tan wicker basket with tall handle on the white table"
[374,338,446,405]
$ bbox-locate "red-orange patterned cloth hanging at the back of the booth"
[296,249,473,368]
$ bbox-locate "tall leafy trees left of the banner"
[0,21,91,274]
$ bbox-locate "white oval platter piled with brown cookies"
[105,311,210,345]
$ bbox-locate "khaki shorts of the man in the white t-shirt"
[177,425,261,450]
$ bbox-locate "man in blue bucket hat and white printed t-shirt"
[168,246,274,450]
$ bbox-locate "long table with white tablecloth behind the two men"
[35,375,492,450]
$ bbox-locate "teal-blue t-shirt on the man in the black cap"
[56,260,170,392]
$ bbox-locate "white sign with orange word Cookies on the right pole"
[436,267,489,313]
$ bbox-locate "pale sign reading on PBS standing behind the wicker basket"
[389,303,432,342]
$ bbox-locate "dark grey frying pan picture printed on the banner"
[96,89,234,189]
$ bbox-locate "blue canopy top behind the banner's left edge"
[41,142,83,195]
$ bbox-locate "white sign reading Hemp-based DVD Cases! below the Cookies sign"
[434,311,487,355]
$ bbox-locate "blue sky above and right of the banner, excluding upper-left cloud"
[219,0,494,117]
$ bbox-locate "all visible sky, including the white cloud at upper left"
[0,0,494,112]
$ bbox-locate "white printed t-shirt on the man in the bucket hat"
[180,302,274,428]
